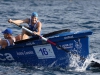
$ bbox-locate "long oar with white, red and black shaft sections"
[17,25,85,60]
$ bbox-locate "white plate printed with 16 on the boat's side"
[33,44,56,59]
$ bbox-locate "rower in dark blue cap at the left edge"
[0,28,15,49]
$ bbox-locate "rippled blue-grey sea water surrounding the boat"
[0,0,100,75]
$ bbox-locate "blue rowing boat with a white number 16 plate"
[0,29,92,67]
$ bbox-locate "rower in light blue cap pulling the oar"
[8,12,42,41]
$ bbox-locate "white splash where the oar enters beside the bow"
[69,53,100,72]
